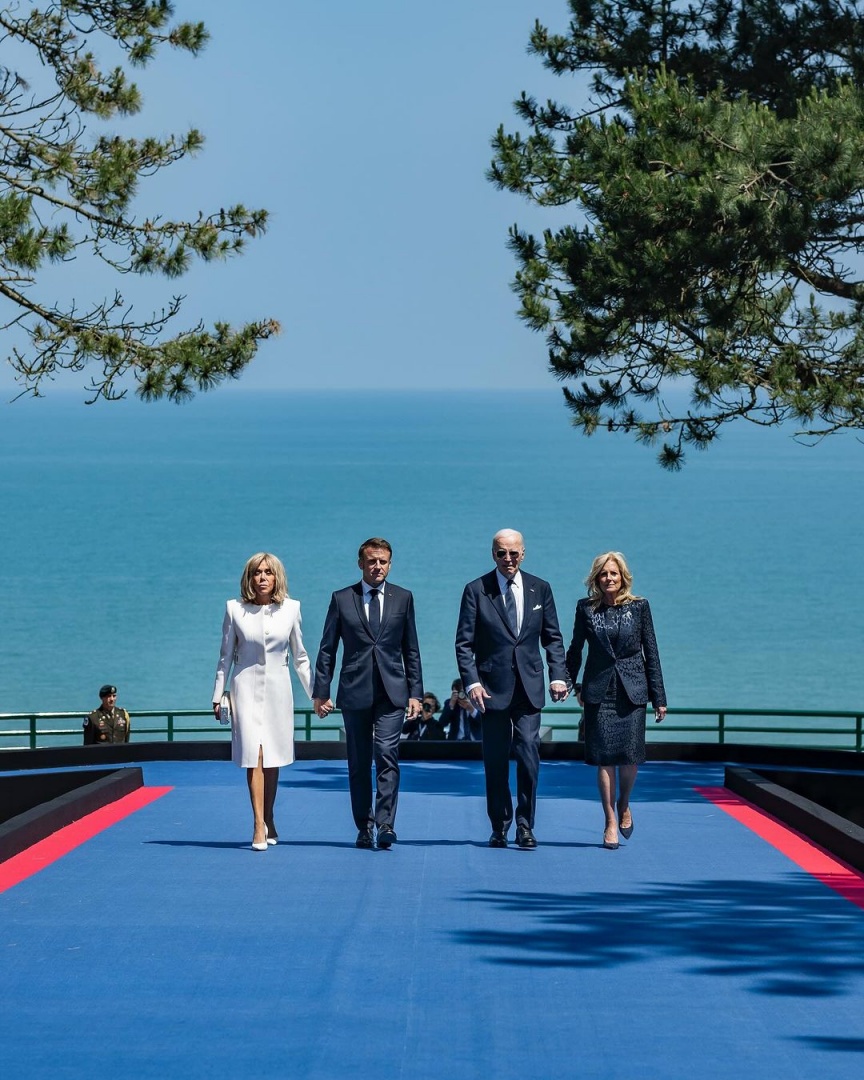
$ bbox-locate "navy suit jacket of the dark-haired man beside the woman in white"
[312,581,423,710]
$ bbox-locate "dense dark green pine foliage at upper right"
[489,0,864,469]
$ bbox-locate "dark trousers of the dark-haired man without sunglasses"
[342,697,405,829]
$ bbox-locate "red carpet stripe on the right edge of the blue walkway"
[694,787,864,908]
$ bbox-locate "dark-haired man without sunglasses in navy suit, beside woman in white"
[312,537,423,848]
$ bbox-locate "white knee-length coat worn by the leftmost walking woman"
[213,598,312,769]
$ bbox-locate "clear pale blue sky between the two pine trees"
[2,0,579,397]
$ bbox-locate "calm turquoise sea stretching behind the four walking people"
[0,388,864,725]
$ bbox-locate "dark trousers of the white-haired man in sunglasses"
[483,683,540,832]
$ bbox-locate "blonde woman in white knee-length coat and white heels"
[213,552,312,851]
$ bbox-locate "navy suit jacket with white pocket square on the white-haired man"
[456,570,567,710]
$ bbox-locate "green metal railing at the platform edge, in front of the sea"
[0,705,864,753]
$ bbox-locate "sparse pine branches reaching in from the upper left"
[0,0,279,401]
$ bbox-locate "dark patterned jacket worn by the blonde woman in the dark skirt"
[567,597,666,708]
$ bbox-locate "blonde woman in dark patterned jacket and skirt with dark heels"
[567,551,666,849]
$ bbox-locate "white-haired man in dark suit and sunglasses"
[456,529,567,848]
